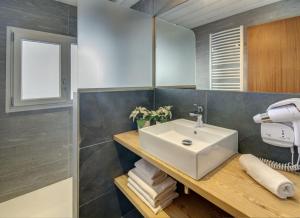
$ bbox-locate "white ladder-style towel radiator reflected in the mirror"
[209,26,244,91]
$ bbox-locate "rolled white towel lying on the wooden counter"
[240,154,295,199]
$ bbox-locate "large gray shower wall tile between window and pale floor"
[0,112,71,204]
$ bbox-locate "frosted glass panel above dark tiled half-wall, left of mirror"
[78,0,152,88]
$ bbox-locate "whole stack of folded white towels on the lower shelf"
[127,159,178,214]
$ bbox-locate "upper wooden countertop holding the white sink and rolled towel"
[114,131,300,217]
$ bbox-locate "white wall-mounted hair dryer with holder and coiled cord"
[253,98,300,171]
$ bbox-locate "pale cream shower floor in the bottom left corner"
[0,178,72,218]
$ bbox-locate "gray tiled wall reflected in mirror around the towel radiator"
[193,0,300,89]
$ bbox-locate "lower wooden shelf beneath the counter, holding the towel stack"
[115,175,230,218]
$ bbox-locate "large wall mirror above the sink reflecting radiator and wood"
[156,0,300,93]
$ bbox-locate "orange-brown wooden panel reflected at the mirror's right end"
[247,17,300,93]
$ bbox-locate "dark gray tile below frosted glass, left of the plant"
[80,90,153,147]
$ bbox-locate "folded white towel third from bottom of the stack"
[128,169,177,200]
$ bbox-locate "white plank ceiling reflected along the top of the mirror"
[159,0,280,28]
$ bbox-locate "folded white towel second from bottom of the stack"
[128,178,179,207]
